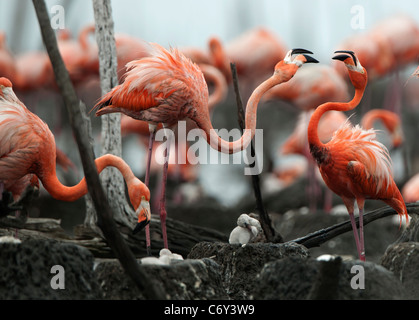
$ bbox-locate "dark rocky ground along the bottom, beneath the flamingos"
[0,195,419,301]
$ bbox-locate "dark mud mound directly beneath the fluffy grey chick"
[188,242,308,300]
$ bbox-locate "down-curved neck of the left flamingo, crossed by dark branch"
[39,154,135,201]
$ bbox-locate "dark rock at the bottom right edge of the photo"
[381,242,419,299]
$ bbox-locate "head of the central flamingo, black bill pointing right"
[274,49,318,82]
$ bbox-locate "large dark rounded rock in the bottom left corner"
[0,240,101,300]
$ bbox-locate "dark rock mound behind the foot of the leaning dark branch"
[95,259,227,300]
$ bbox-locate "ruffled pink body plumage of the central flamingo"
[94,44,208,123]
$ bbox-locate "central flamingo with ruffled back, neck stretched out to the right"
[93,44,317,251]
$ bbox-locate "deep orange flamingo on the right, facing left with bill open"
[307,51,408,261]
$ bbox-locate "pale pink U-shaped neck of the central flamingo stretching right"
[198,73,284,153]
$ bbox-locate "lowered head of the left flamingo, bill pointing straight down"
[128,180,151,234]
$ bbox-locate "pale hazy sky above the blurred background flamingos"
[0,0,419,59]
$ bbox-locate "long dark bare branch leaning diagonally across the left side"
[33,0,164,299]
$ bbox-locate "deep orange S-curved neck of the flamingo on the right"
[307,87,365,149]
